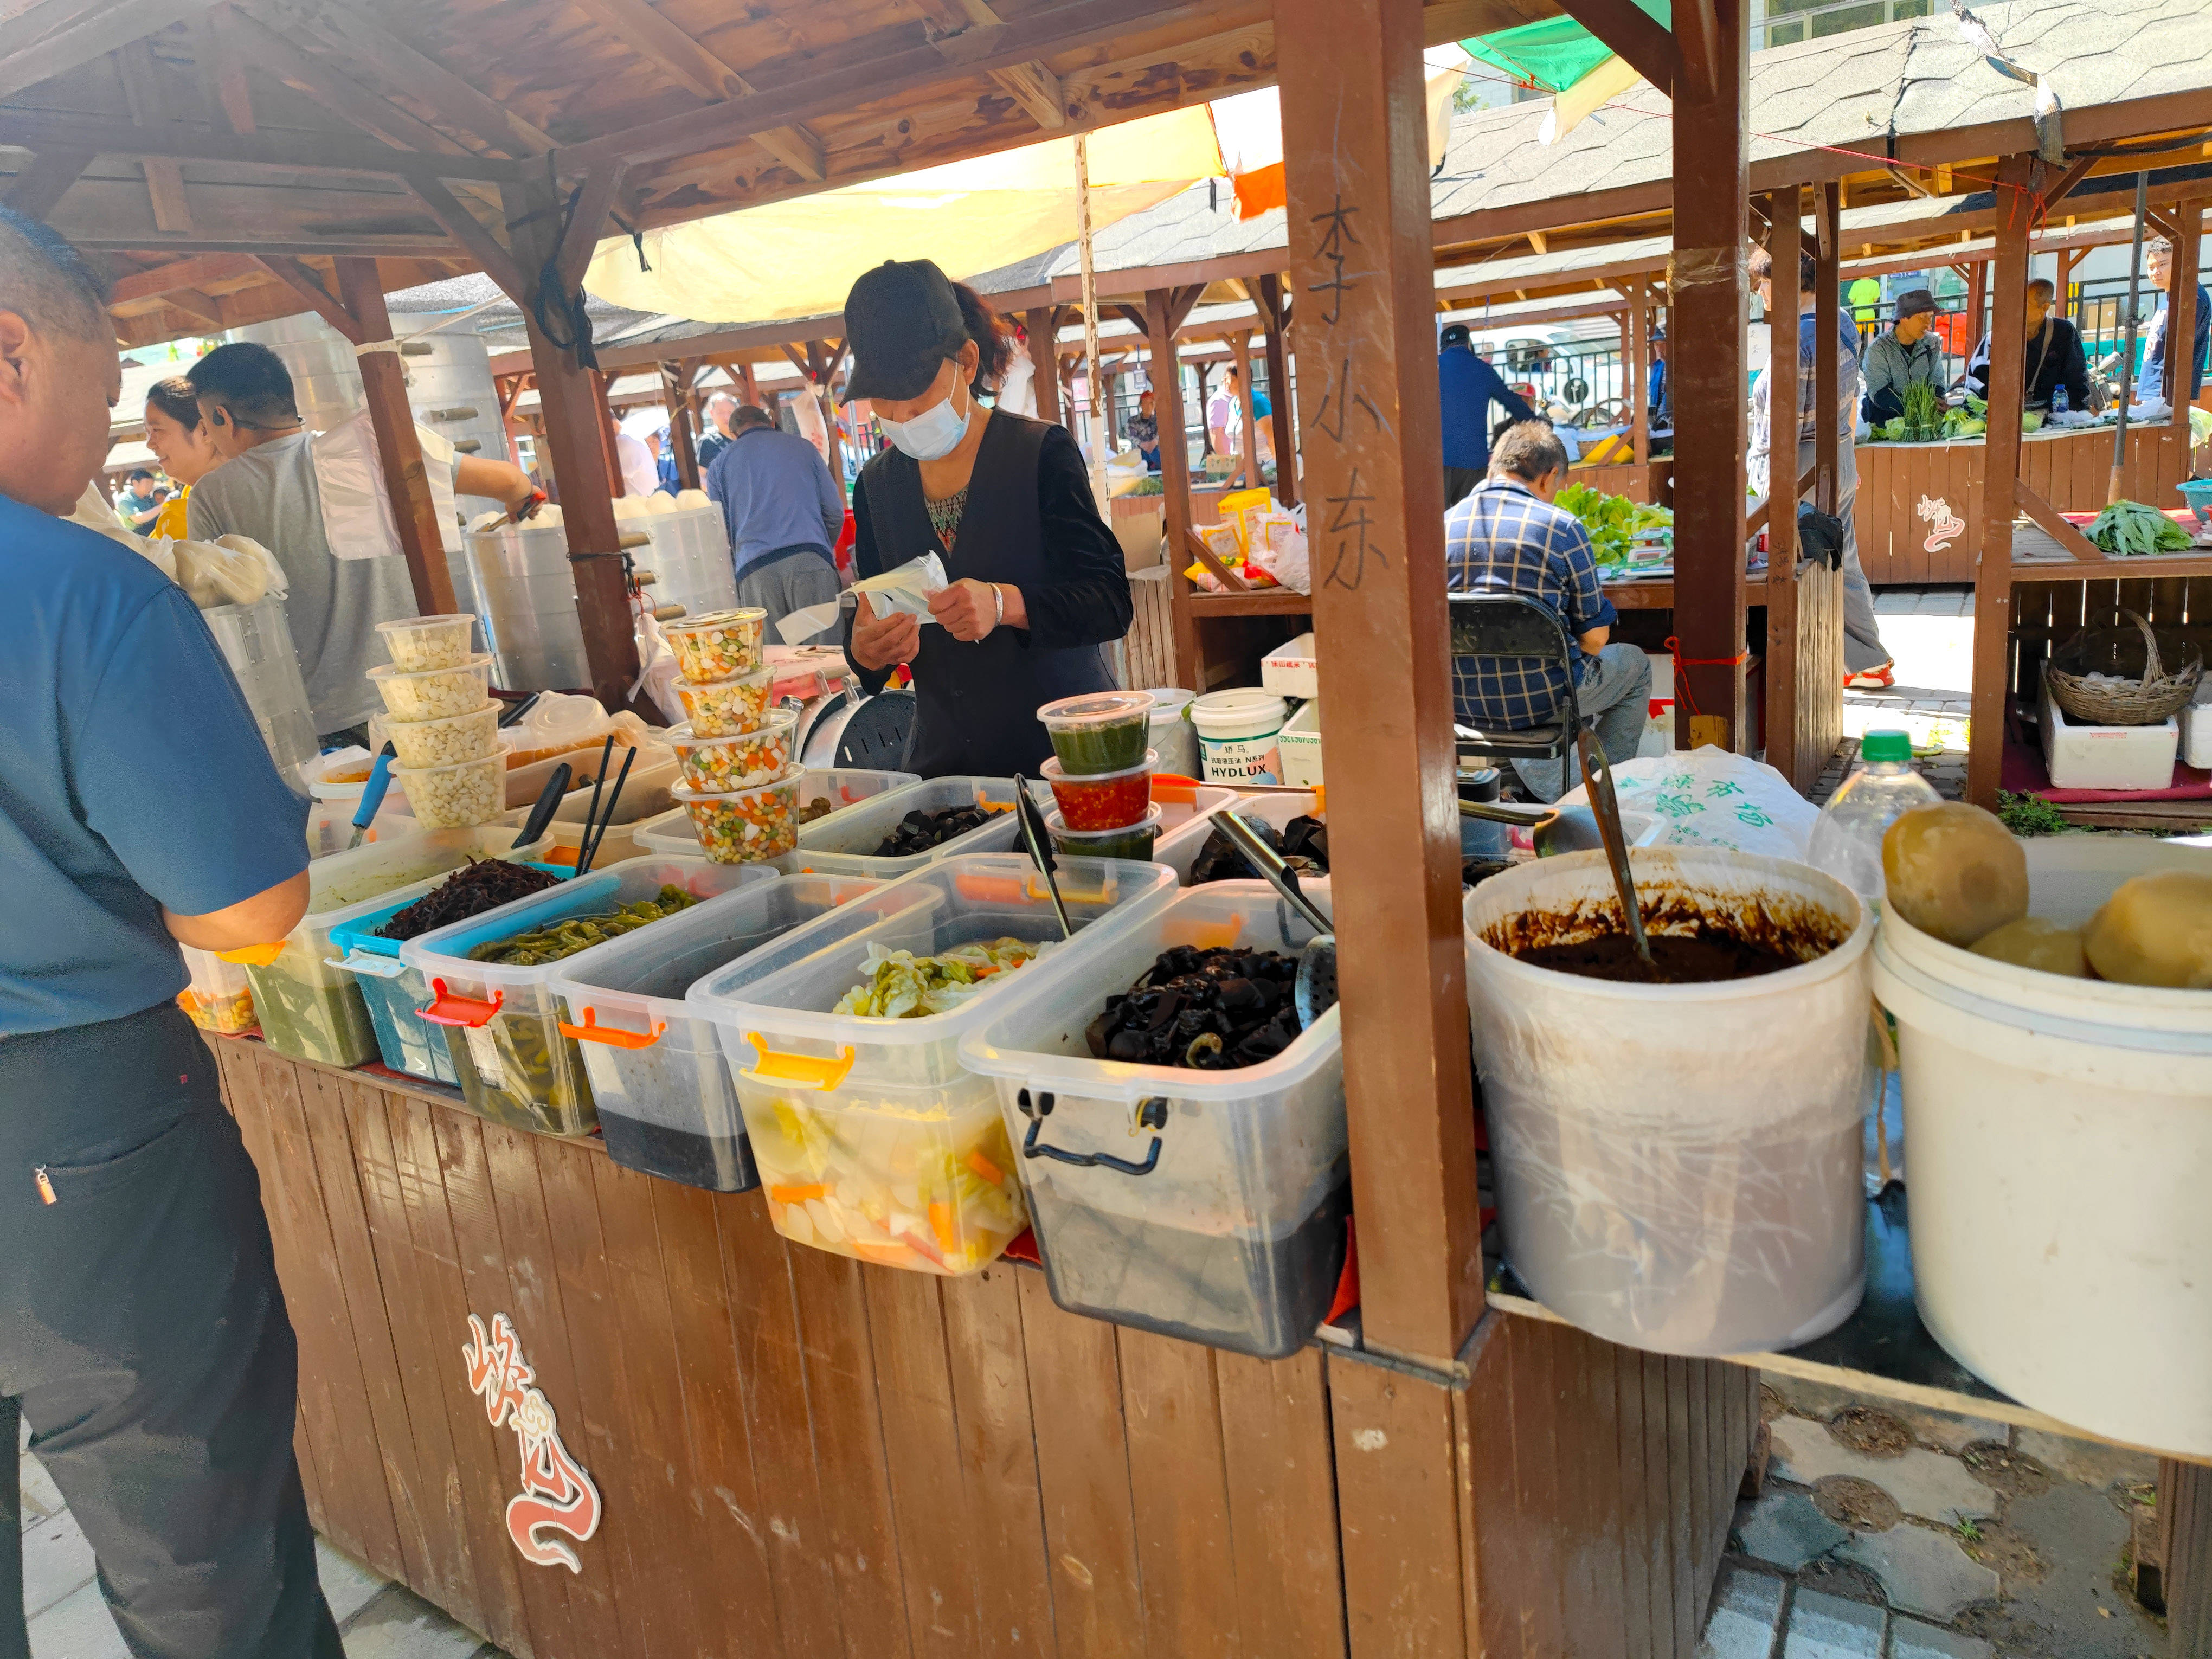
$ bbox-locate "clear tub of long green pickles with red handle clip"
[400,856,776,1135]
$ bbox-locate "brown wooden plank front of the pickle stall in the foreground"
[210,1040,1757,1659]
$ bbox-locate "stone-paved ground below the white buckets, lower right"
[1699,1374,2168,1659]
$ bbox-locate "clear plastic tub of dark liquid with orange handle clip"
[553,876,876,1192]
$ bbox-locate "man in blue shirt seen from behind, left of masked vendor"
[703,405,845,646]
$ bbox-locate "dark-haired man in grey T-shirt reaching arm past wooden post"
[186,340,542,748]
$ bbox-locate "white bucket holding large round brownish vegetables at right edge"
[1874,836,2212,1458]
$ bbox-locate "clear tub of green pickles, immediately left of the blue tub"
[223,823,544,1066]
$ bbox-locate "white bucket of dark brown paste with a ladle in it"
[1462,847,1872,1356]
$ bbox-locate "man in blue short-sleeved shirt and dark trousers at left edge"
[0,208,340,1659]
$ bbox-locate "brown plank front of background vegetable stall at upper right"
[1856,425,2190,586]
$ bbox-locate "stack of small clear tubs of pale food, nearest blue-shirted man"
[369,615,506,829]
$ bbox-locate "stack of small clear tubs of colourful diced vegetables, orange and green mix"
[664,608,799,865]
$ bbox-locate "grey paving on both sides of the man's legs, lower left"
[20,1416,502,1659]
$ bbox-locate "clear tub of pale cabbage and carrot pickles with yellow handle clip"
[686,854,1174,1274]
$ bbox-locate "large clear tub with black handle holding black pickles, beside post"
[960,880,1352,1358]
